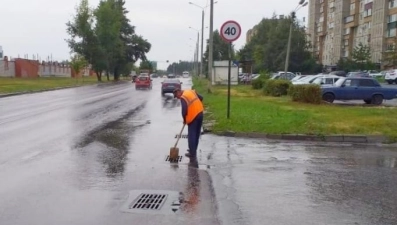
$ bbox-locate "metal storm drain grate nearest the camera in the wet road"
[129,193,168,210]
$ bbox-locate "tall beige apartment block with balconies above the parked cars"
[308,0,397,68]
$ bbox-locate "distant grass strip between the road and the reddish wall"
[0,77,106,94]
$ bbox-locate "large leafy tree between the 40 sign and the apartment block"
[237,14,319,73]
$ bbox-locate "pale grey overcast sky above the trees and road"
[0,0,308,69]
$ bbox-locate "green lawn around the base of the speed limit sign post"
[193,78,397,139]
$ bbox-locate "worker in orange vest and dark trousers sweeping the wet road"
[174,89,204,159]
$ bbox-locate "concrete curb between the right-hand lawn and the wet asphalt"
[212,131,390,144]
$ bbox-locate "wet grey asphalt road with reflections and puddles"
[0,79,397,225]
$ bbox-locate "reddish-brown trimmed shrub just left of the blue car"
[288,84,322,104]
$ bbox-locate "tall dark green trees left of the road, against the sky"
[66,0,151,81]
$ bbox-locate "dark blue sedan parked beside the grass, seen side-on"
[321,77,397,105]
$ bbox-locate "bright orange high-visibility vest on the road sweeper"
[181,90,204,124]
